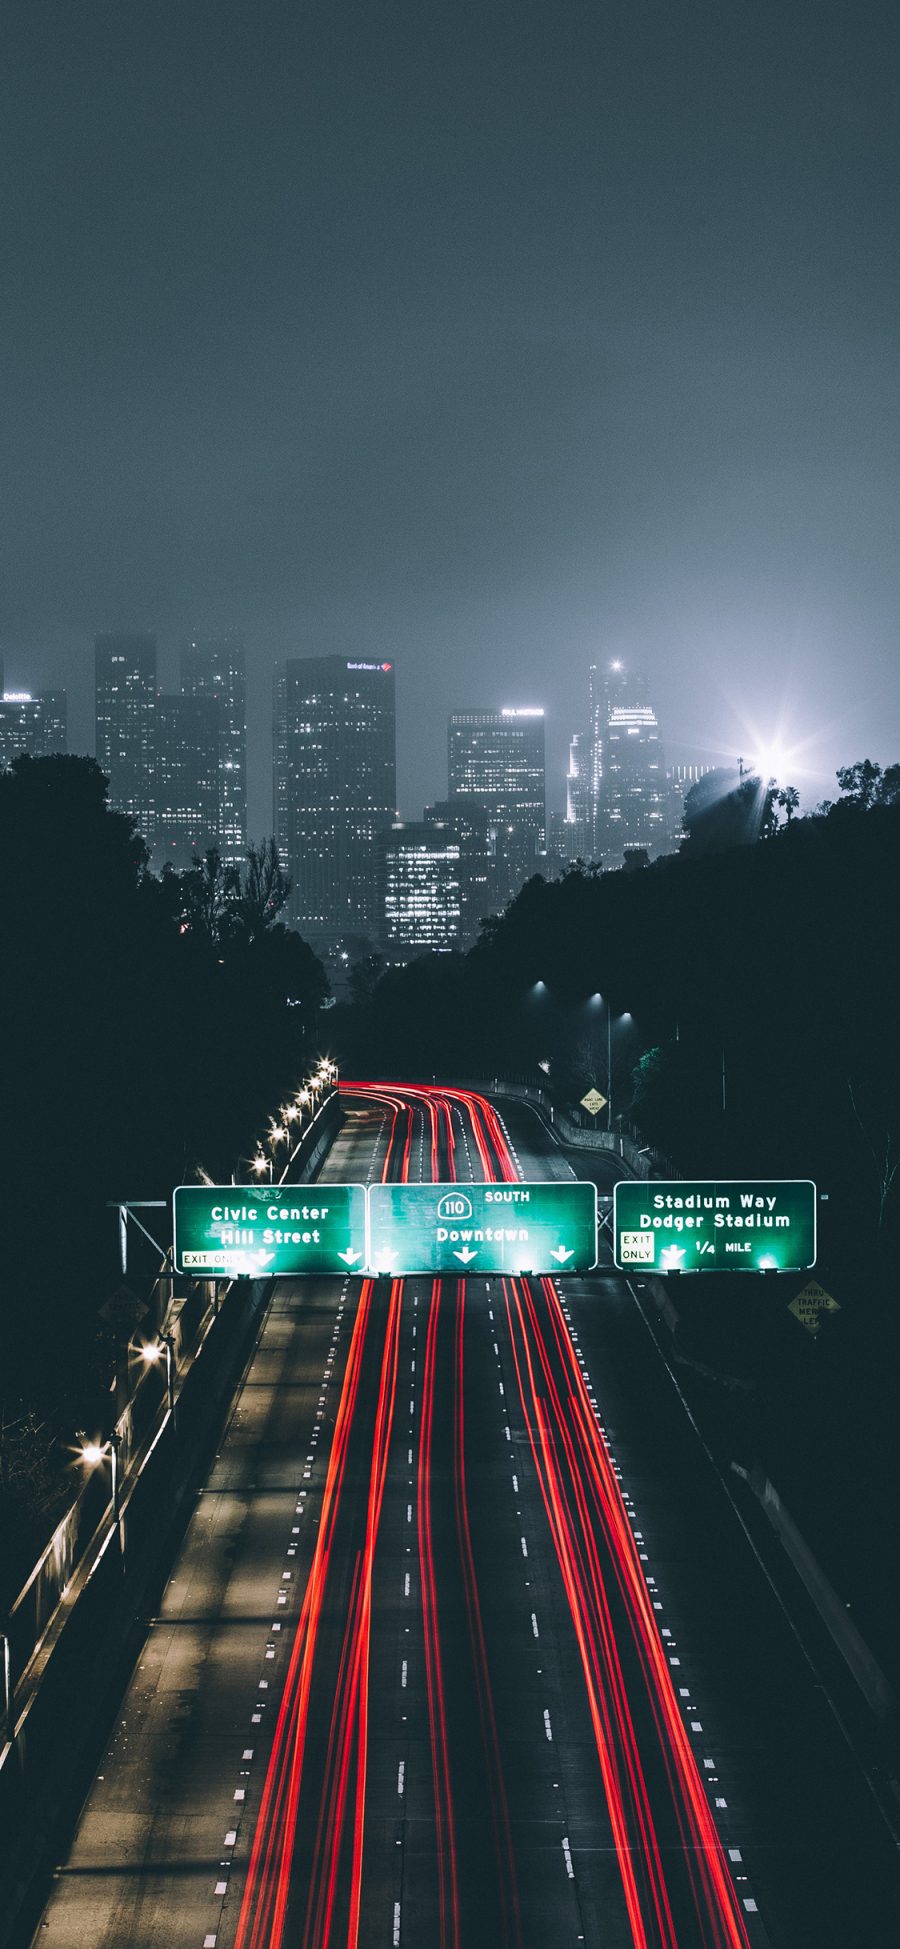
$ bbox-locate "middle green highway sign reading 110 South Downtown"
[368,1183,596,1277]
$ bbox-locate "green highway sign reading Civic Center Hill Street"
[171,1183,366,1279]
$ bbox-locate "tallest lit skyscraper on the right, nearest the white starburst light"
[590,661,668,865]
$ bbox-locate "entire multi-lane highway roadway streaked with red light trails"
[28,1084,900,1949]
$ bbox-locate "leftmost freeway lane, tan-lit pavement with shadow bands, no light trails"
[28,1113,386,1949]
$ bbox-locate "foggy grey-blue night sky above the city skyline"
[0,0,900,834]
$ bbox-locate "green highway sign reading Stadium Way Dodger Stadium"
[612,1177,816,1273]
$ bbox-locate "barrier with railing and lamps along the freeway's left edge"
[0,1091,341,1949]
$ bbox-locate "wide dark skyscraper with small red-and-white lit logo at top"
[275,657,397,943]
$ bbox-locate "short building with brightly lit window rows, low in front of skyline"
[380,819,462,955]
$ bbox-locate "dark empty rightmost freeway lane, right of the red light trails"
[492,1105,900,1949]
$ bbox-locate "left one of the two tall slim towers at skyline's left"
[94,635,156,840]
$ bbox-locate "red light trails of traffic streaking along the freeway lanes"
[236,1084,748,1949]
